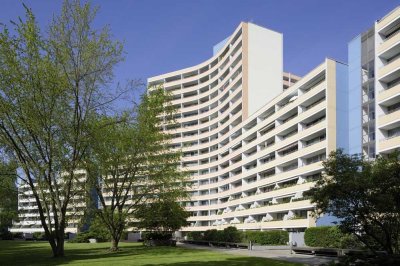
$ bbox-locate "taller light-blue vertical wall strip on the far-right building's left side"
[348,35,362,154]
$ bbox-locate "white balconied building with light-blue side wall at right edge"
[348,7,400,159]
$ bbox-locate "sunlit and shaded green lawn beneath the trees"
[0,241,300,266]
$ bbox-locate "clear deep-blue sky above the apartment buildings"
[0,0,400,82]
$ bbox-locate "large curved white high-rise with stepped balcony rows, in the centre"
[148,23,348,231]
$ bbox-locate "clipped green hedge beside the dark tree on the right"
[304,226,345,248]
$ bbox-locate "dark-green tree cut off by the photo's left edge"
[0,158,18,235]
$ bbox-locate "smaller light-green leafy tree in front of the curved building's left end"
[86,88,186,251]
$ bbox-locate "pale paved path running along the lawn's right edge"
[178,243,335,265]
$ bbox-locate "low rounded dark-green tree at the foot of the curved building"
[135,199,190,232]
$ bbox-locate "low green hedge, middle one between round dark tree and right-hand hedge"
[243,230,289,245]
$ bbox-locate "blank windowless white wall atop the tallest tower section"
[248,23,283,116]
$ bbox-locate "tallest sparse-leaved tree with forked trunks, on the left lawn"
[0,0,123,257]
